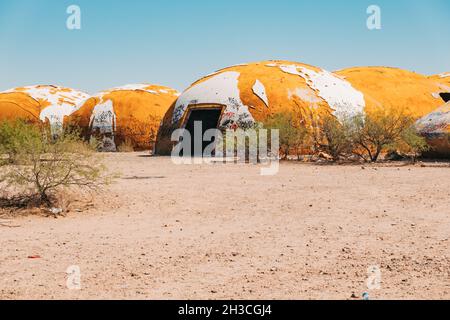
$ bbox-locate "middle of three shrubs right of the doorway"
[314,115,354,161]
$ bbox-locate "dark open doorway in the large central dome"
[185,108,222,157]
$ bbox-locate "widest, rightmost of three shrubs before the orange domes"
[353,110,414,162]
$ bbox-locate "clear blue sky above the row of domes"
[0,0,450,93]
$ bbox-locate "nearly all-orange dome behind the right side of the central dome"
[336,67,443,118]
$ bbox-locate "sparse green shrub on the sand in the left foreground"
[0,121,113,206]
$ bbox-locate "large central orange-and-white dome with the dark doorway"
[156,61,365,154]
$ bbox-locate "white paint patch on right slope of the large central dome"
[280,65,366,116]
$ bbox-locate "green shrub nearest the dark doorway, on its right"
[264,112,309,159]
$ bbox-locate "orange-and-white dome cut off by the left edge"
[0,85,89,127]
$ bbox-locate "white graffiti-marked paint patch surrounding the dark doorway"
[172,71,254,127]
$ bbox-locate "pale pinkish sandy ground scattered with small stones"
[0,153,450,299]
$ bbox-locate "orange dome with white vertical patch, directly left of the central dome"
[68,84,179,151]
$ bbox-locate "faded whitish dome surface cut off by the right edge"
[416,102,450,135]
